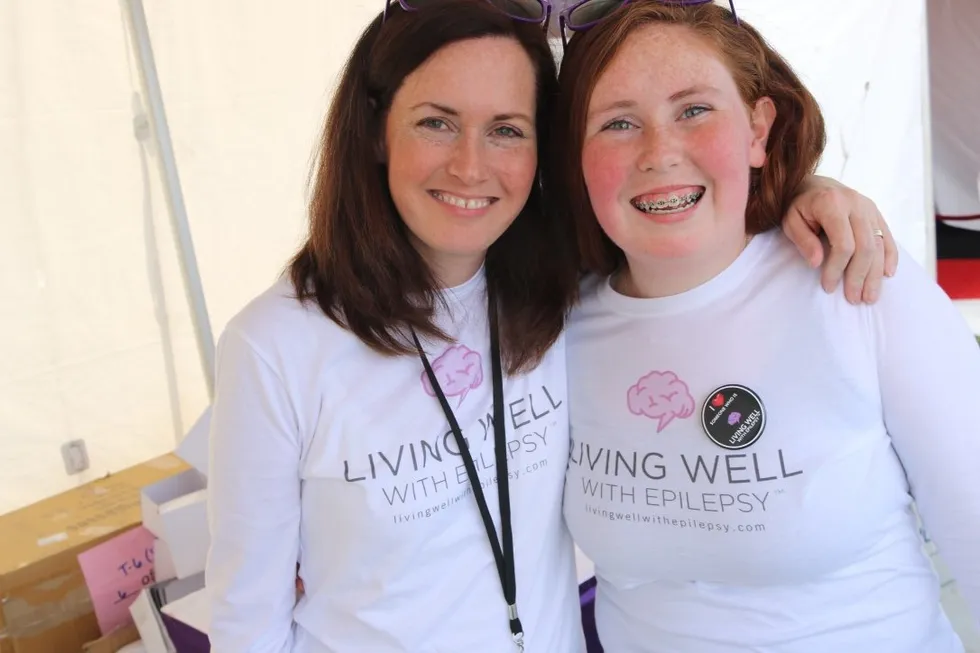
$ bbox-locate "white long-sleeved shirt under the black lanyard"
[207,272,584,653]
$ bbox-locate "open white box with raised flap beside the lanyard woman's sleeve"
[141,408,211,580]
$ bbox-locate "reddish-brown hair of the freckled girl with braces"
[549,0,826,275]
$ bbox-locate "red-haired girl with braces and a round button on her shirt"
[552,0,980,653]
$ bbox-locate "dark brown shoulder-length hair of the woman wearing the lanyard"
[290,0,577,374]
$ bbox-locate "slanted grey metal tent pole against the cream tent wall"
[122,0,214,400]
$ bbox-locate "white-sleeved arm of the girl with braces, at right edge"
[875,252,980,619]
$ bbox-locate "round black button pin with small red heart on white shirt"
[701,385,766,449]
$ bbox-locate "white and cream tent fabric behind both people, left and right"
[0,0,980,512]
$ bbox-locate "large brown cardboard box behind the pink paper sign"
[0,454,188,653]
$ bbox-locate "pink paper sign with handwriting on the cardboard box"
[78,526,156,635]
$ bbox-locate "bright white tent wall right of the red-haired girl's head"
[748,0,932,268]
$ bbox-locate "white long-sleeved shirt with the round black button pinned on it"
[565,232,980,653]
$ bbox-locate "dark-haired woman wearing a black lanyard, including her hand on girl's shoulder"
[207,0,912,653]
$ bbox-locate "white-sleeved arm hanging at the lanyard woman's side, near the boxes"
[206,326,302,653]
